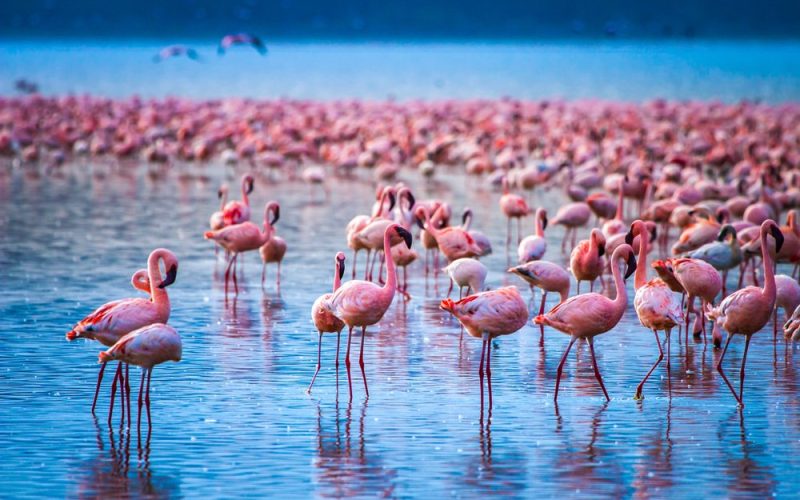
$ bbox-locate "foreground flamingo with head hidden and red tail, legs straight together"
[440,286,528,414]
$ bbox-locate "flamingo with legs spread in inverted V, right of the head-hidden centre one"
[533,244,636,401]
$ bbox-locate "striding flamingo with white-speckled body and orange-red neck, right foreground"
[627,220,683,400]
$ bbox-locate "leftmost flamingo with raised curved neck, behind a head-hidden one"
[66,248,178,424]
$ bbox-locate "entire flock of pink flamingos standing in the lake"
[0,96,800,434]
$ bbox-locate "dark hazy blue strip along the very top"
[0,0,800,39]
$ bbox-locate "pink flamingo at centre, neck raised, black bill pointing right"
[328,224,412,400]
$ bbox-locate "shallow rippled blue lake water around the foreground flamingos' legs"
[0,165,800,498]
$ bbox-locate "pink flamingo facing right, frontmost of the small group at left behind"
[204,201,280,296]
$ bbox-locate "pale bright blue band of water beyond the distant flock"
[0,40,800,102]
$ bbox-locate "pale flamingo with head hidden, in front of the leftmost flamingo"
[98,323,182,429]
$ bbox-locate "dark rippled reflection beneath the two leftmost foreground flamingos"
[70,419,181,498]
